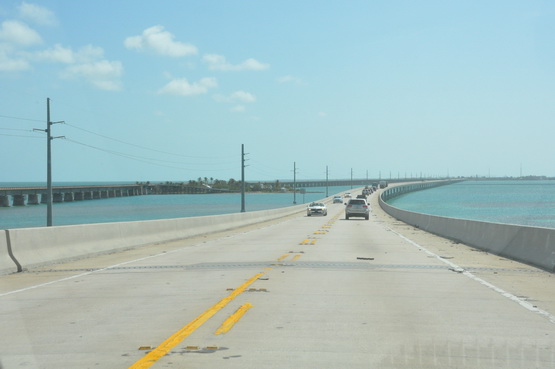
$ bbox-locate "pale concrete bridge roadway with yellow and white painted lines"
[0,191,555,369]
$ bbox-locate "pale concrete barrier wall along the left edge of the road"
[0,198,312,274]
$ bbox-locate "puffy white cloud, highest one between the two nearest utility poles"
[124,26,198,57]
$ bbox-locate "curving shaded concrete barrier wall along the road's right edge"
[379,186,555,272]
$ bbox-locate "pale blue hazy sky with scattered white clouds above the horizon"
[0,0,555,182]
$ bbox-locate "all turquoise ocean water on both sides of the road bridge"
[5,180,555,229]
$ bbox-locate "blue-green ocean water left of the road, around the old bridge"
[0,182,351,229]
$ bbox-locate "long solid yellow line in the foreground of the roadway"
[129,273,264,369]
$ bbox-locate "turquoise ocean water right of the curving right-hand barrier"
[388,180,555,228]
